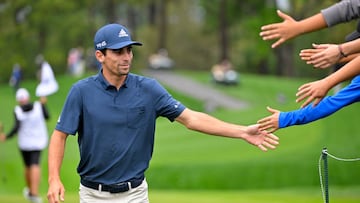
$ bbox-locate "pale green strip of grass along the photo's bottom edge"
[0,187,360,203]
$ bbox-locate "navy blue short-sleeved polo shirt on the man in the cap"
[56,71,185,184]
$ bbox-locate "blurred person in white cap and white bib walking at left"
[0,88,49,203]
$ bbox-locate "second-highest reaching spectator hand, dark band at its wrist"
[299,44,341,68]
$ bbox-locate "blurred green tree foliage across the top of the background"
[0,0,356,83]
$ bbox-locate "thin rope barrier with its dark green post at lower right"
[319,148,360,203]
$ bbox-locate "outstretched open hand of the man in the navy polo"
[244,124,279,152]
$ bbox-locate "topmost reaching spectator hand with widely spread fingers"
[260,10,300,48]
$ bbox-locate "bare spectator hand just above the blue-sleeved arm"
[296,79,331,108]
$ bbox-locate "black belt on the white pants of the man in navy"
[80,178,144,193]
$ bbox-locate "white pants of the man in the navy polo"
[79,179,149,203]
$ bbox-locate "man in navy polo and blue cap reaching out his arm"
[48,24,278,203]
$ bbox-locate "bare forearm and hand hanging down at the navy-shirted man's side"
[47,130,68,203]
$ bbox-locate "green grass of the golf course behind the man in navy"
[0,72,360,203]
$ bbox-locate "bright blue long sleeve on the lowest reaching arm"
[279,76,360,128]
